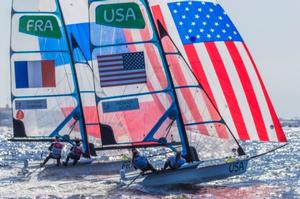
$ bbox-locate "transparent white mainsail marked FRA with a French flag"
[11,0,91,150]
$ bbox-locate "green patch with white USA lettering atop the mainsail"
[96,3,145,29]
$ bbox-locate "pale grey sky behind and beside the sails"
[0,0,300,118]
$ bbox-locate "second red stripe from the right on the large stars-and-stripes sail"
[225,42,269,141]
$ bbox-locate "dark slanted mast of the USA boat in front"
[145,0,191,162]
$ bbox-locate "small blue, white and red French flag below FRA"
[15,60,56,88]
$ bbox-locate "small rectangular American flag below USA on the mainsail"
[98,52,147,87]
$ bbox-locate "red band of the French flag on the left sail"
[41,60,56,87]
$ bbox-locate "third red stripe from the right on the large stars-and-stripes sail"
[205,42,249,140]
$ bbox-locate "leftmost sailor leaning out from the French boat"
[40,136,64,167]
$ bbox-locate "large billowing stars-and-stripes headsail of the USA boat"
[150,0,286,142]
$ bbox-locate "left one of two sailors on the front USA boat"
[132,148,157,172]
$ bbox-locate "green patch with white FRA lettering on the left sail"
[19,15,61,38]
